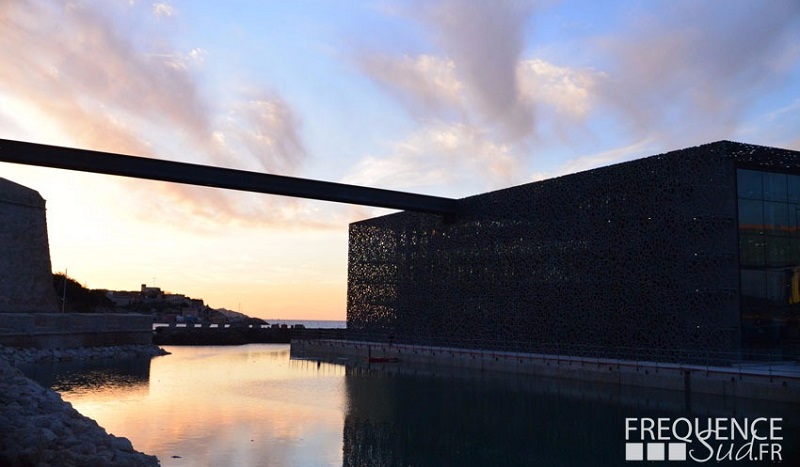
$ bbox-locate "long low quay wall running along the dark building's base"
[291,339,800,403]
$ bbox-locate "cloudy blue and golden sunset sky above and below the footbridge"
[0,0,800,320]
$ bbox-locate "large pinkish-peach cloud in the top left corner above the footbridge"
[0,1,210,154]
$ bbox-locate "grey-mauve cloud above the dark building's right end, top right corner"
[593,0,800,145]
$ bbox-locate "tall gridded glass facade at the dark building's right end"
[737,169,800,350]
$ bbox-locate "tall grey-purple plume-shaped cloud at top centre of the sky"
[356,0,534,142]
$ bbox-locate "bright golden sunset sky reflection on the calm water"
[24,345,344,466]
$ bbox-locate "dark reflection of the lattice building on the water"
[342,367,798,467]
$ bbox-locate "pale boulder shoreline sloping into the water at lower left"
[0,345,166,467]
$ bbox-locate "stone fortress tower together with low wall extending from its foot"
[0,178,153,349]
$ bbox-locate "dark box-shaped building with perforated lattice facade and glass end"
[347,141,800,360]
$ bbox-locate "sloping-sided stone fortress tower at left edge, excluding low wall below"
[0,178,58,313]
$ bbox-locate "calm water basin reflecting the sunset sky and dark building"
[20,344,800,466]
